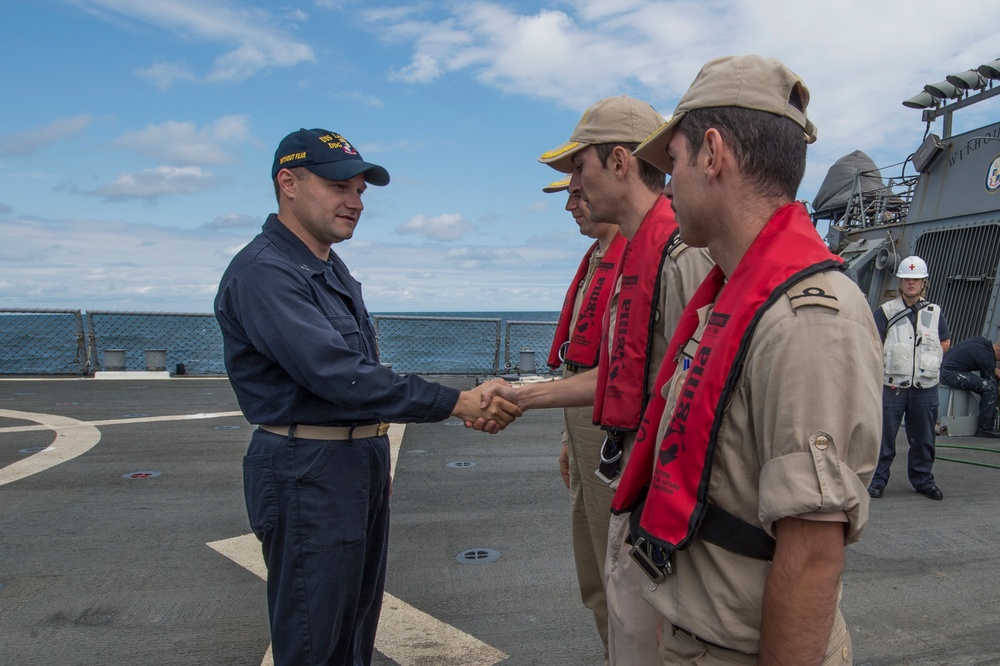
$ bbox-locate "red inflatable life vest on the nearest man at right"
[611,203,843,550]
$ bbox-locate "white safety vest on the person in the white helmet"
[882,297,944,388]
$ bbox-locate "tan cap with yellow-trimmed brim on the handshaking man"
[538,95,663,173]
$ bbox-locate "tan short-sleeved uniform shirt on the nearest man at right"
[644,271,882,654]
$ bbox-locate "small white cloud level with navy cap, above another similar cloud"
[114,115,250,166]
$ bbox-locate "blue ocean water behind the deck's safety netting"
[0,310,559,375]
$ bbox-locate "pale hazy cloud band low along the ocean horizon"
[0,210,589,313]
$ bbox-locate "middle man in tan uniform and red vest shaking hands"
[480,96,712,666]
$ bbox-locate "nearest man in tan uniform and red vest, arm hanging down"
[612,56,882,665]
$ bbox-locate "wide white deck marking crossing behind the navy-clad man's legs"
[208,424,507,666]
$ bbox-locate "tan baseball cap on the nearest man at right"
[635,55,816,173]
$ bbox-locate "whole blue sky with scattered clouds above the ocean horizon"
[0,0,1000,312]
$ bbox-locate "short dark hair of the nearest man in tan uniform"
[677,106,806,200]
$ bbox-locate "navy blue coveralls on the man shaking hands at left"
[215,215,459,666]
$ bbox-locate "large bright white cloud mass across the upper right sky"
[362,0,1000,198]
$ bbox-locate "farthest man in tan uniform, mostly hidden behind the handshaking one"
[542,171,627,660]
